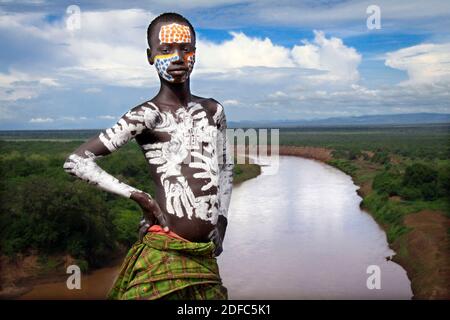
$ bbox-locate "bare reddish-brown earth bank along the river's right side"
[279,146,450,299]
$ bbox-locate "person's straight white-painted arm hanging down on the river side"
[212,103,234,256]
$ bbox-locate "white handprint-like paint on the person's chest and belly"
[142,103,219,224]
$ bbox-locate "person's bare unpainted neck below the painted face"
[155,79,192,106]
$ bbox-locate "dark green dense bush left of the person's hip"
[0,176,116,265]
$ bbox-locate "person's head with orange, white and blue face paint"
[147,12,195,83]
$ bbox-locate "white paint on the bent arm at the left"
[64,106,162,198]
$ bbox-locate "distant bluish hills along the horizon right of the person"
[229,112,450,128]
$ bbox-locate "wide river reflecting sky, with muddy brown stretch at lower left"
[22,156,412,299]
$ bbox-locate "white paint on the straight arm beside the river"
[214,104,234,218]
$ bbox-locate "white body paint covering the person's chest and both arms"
[64,103,233,224]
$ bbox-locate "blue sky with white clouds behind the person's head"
[0,0,450,130]
